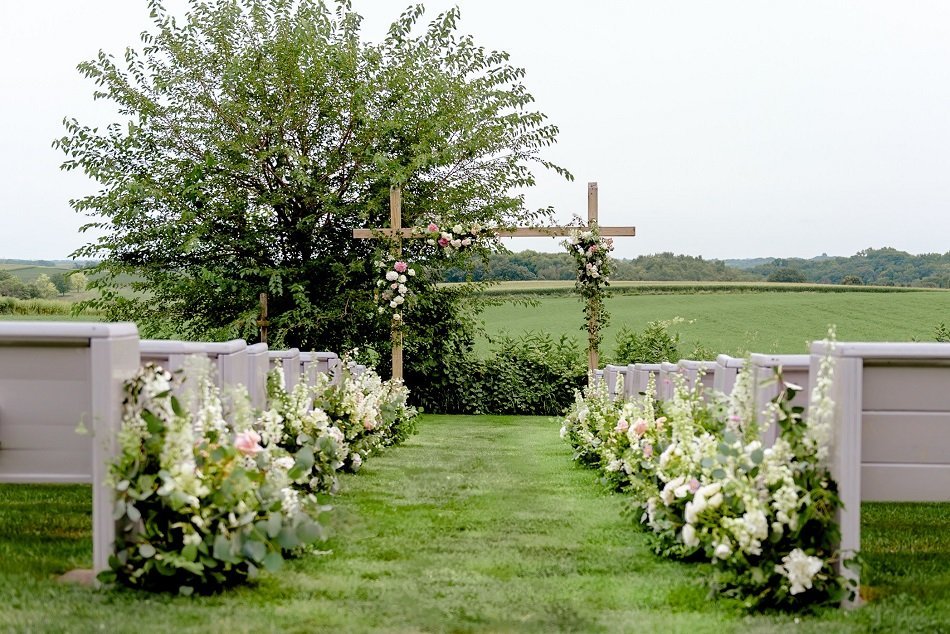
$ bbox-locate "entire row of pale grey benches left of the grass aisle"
[0,322,346,571]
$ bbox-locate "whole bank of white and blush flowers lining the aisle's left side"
[100,356,416,594]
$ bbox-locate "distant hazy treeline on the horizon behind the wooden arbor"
[445,247,950,288]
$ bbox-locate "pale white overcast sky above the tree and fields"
[0,0,950,259]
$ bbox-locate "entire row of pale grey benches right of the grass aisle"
[603,342,950,604]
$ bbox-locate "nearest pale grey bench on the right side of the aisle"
[811,342,950,600]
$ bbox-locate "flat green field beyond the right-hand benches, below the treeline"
[478,291,950,356]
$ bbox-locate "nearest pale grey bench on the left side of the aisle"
[0,322,139,572]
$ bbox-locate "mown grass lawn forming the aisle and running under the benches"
[0,416,950,634]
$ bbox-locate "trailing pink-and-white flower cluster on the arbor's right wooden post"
[562,222,614,349]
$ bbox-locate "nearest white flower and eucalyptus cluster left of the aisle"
[100,357,325,594]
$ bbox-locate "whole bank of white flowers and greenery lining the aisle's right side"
[561,340,853,609]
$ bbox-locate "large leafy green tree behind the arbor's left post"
[54,0,570,349]
